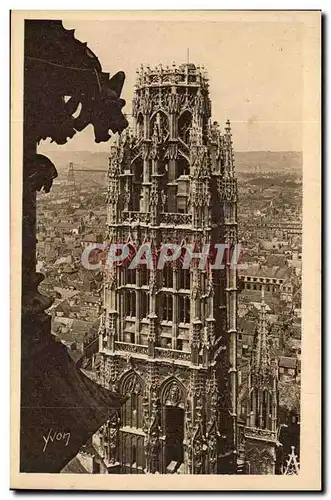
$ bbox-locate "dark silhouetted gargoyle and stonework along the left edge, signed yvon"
[20,20,128,473]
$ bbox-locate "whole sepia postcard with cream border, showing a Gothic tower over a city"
[11,11,321,490]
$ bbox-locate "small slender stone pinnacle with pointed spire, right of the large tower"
[244,289,278,474]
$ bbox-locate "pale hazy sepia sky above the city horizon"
[40,16,303,151]
